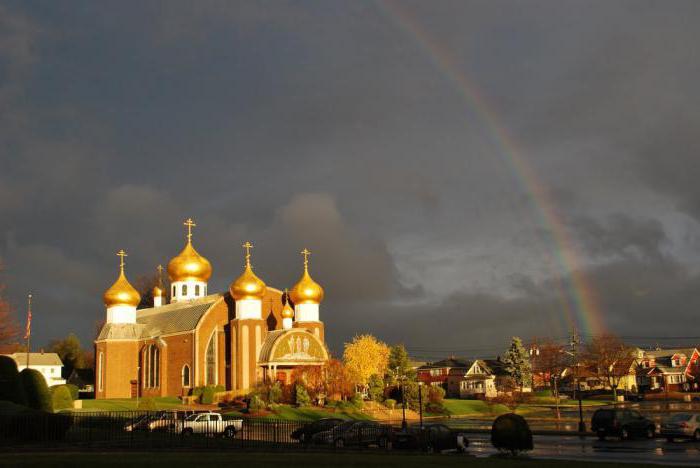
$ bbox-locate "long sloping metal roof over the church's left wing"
[97,294,222,341]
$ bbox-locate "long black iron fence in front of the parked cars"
[0,411,392,450]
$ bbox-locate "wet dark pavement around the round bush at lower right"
[468,434,700,466]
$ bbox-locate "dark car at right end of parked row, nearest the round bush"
[392,424,469,453]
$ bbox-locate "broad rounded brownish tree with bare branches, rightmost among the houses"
[584,334,634,400]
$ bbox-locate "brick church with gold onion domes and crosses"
[95,219,328,398]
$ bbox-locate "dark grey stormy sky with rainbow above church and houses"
[0,0,700,359]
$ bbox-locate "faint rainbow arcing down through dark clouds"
[376,0,605,335]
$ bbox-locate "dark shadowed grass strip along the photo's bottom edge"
[2,452,680,468]
